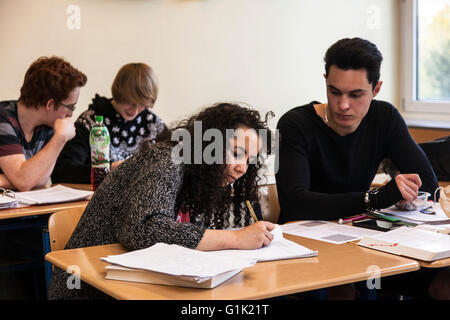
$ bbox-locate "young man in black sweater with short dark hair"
[276,38,444,300]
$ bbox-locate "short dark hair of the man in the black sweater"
[324,38,383,88]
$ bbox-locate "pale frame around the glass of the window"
[400,0,450,116]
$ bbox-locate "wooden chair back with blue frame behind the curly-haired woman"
[44,207,86,288]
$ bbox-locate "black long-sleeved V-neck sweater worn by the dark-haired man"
[276,100,437,223]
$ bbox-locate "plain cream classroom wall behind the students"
[0,0,400,127]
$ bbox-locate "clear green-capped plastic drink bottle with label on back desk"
[89,116,111,191]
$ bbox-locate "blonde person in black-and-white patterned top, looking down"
[52,63,167,183]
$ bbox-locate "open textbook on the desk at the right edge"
[358,226,450,261]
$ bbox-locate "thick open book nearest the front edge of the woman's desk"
[101,243,256,288]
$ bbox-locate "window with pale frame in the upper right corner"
[401,0,450,114]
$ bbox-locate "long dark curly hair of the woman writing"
[157,103,273,229]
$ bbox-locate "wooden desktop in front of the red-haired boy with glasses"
[0,183,90,220]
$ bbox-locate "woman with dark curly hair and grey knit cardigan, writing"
[49,103,274,299]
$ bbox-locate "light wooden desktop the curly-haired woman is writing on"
[46,234,419,300]
